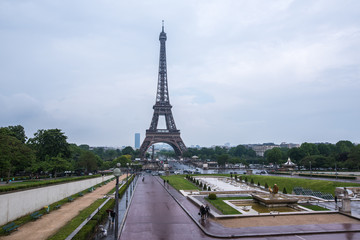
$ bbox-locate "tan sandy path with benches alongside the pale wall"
[0,175,126,240]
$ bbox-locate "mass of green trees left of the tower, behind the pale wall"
[0,125,138,179]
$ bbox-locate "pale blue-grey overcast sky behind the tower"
[0,0,360,147]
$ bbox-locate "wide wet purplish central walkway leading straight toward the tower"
[120,176,218,240]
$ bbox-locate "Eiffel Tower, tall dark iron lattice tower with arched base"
[140,21,187,159]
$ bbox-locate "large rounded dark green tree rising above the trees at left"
[29,129,71,161]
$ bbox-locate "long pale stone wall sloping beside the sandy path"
[0,175,113,225]
